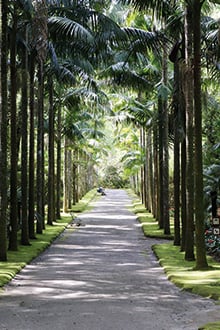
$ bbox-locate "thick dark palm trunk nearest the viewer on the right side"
[193,0,208,269]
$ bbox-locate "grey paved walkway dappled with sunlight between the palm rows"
[0,190,219,330]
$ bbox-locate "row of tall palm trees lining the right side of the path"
[113,0,218,269]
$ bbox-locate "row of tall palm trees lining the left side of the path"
[0,0,120,260]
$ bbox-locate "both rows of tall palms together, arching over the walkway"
[0,0,219,269]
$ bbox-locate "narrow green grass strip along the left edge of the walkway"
[0,190,97,288]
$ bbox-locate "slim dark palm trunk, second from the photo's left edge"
[9,4,18,251]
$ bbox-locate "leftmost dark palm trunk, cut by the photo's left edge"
[0,0,8,261]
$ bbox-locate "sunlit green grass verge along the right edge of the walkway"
[132,193,220,330]
